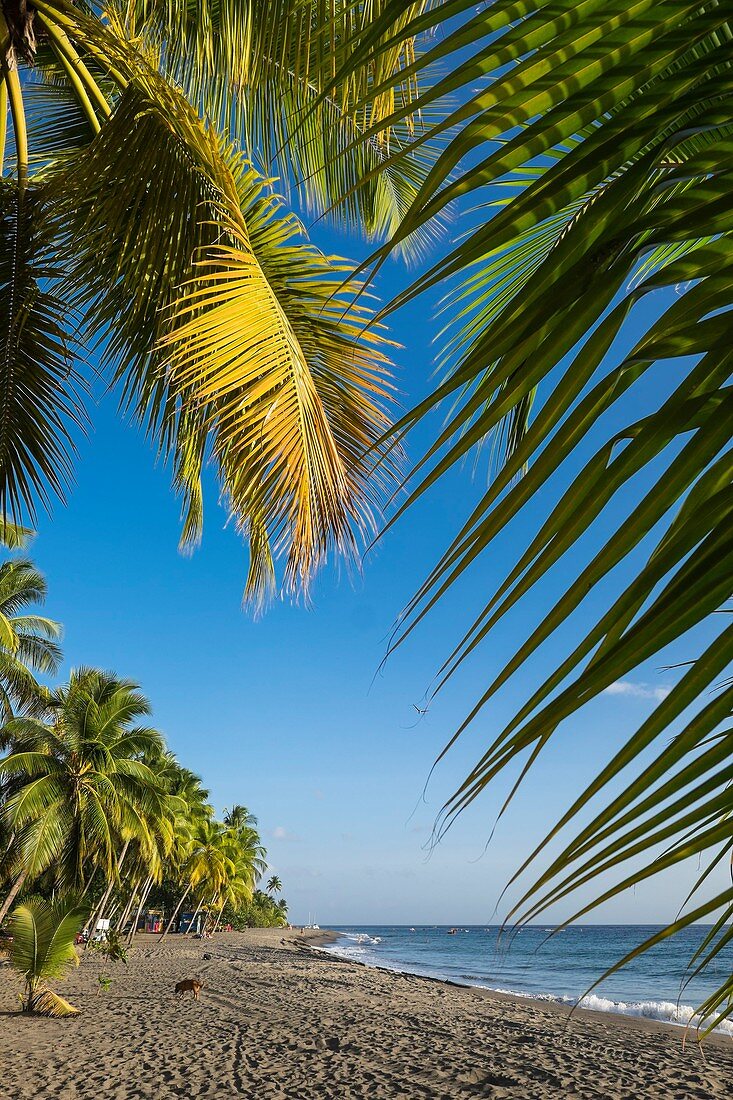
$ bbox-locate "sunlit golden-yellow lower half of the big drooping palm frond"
[162,160,389,602]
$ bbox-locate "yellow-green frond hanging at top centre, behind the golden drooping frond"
[119,0,445,255]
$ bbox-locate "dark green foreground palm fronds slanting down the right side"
[338,0,733,1025]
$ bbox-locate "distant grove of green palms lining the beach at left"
[0,523,286,939]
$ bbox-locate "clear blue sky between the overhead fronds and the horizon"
[22,207,717,925]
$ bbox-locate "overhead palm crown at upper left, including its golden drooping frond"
[0,0,442,598]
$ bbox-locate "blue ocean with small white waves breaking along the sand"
[324,924,733,1036]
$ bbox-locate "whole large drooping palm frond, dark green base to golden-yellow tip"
[52,75,390,598]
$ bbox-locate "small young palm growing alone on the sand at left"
[10,898,86,1016]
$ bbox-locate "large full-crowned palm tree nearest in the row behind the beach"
[0,669,168,921]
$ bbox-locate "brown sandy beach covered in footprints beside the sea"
[0,930,733,1100]
